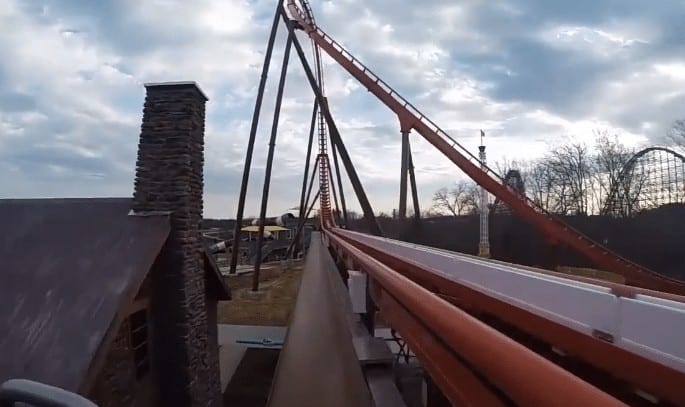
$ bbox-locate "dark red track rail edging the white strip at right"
[329,229,685,405]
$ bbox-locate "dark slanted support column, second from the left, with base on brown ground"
[252,34,293,291]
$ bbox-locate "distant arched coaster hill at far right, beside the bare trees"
[602,147,685,217]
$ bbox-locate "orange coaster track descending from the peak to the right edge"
[287,0,685,295]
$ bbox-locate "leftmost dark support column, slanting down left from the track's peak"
[230,6,281,274]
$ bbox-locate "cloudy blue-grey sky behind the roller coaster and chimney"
[0,0,685,218]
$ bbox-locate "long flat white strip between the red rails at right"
[340,230,685,372]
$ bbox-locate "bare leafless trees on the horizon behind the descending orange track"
[431,120,685,216]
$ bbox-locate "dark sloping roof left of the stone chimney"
[0,198,229,391]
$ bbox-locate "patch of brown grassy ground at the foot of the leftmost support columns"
[219,260,302,326]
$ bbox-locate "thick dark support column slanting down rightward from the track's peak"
[279,6,382,236]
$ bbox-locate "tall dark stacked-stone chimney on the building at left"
[132,82,221,407]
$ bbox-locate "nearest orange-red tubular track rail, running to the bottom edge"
[326,231,625,406]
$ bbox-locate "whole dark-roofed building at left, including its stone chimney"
[0,83,230,407]
